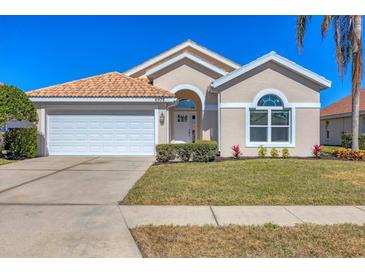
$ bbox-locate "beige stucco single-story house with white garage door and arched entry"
[28,40,331,156]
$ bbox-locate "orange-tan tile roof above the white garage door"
[27,72,174,98]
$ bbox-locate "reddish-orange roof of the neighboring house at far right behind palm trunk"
[321,89,365,118]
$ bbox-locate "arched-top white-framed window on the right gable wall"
[249,94,291,145]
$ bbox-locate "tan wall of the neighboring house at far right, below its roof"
[321,115,365,146]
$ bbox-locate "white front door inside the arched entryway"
[174,111,196,143]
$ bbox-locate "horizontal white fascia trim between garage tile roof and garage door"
[29,97,176,103]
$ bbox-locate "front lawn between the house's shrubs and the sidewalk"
[121,159,365,205]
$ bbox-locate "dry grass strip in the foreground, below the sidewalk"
[132,224,365,258]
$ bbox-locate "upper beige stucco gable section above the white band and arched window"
[220,62,319,103]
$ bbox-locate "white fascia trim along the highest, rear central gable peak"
[125,40,240,76]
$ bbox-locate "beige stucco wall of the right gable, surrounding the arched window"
[220,63,320,157]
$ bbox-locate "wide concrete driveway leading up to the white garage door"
[0,156,153,257]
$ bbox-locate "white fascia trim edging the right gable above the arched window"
[212,51,331,89]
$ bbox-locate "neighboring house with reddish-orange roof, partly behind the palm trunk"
[321,89,365,146]
